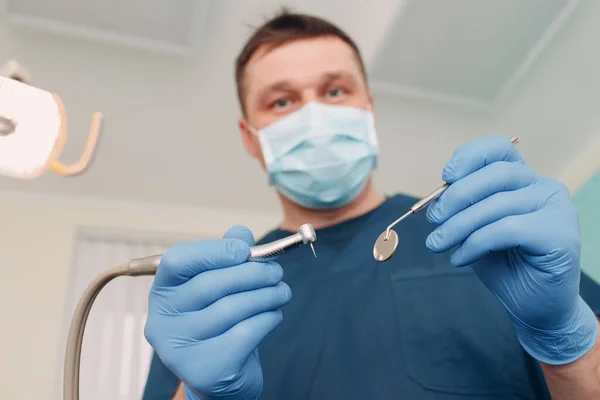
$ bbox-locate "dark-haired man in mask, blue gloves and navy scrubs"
[145,9,600,400]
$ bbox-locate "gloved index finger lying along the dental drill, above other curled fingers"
[153,239,250,287]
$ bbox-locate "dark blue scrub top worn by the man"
[144,195,600,400]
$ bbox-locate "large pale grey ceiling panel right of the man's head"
[370,0,574,104]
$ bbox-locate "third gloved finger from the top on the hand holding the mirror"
[425,185,541,253]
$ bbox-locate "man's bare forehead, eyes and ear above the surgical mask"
[240,37,372,167]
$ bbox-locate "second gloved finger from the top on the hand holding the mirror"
[426,161,536,224]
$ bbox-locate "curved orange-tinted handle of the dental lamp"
[48,93,103,176]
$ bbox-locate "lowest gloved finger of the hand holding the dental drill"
[209,309,283,368]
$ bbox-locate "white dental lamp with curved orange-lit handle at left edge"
[0,76,103,180]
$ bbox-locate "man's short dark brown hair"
[235,9,367,114]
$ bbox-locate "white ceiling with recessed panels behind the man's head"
[0,0,600,211]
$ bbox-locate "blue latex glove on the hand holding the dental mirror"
[426,137,598,364]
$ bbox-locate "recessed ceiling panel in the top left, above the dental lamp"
[7,0,208,55]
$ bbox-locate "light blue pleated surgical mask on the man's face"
[252,103,379,209]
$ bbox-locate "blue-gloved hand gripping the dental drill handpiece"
[144,227,291,400]
